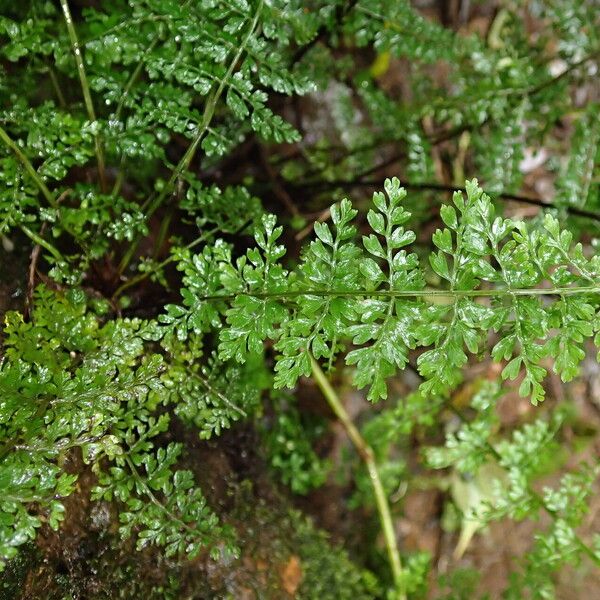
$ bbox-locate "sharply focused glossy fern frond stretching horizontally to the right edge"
[170,179,600,404]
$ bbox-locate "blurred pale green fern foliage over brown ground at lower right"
[426,392,600,598]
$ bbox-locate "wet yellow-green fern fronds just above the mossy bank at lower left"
[0,288,234,562]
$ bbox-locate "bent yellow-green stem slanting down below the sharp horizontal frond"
[309,355,406,600]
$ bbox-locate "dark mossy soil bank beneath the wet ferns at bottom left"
[0,481,379,600]
